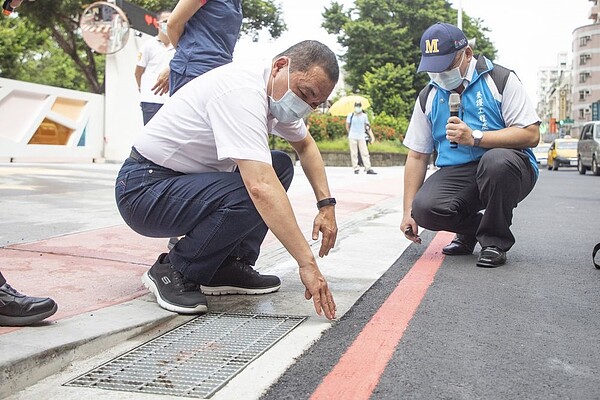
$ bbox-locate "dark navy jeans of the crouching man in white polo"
[115,151,294,284]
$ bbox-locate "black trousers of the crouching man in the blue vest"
[412,148,537,251]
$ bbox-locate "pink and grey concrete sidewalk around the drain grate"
[0,164,409,398]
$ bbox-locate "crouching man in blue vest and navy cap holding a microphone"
[400,22,540,267]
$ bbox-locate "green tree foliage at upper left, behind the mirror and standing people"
[0,0,286,93]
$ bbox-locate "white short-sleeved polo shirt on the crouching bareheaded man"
[134,62,307,173]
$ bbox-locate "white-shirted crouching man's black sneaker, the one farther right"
[200,258,281,296]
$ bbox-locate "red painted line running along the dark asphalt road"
[310,232,454,400]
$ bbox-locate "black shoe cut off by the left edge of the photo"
[0,283,58,326]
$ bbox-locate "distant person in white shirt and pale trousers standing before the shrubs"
[346,102,377,175]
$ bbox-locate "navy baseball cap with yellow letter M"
[417,22,468,72]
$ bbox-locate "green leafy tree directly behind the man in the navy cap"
[322,0,496,116]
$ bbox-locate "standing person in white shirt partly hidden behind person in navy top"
[135,11,175,125]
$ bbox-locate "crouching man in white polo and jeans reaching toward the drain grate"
[115,41,339,319]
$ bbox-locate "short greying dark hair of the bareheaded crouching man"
[275,40,340,83]
